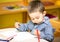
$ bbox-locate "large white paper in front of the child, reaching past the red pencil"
[10,32,47,42]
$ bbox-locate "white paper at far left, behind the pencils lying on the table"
[0,28,18,39]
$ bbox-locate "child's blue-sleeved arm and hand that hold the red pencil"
[32,25,53,41]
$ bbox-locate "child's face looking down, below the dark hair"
[29,11,45,24]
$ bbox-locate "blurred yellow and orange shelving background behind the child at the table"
[0,0,60,42]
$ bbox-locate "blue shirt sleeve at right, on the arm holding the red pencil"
[40,18,54,41]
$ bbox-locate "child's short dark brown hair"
[28,0,45,13]
